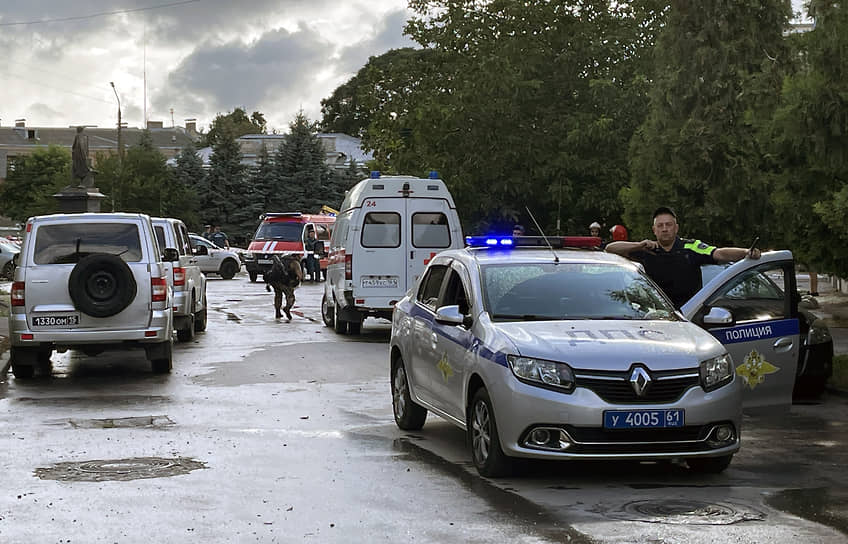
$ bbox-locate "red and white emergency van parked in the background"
[244,212,336,282]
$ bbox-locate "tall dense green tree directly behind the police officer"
[622,0,791,245]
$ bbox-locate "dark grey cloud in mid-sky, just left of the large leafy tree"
[154,27,332,118]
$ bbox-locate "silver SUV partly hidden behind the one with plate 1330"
[151,217,206,342]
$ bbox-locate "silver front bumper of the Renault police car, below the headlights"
[487,368,742,460]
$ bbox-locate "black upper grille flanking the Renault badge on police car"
[574,369,700,404]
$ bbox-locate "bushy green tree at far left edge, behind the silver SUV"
[0,145,71,221]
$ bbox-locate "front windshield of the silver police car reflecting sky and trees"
[481,263,678,321]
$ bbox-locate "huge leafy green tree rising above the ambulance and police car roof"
[324,0,662,232]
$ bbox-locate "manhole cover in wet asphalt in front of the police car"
[606,499,766,525]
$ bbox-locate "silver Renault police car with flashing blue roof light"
[390,237,798,477]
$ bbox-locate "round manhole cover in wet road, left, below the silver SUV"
[35,457,206,482]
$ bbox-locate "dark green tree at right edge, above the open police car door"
[765,1,848,276]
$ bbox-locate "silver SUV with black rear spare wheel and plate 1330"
[9,213,173,378]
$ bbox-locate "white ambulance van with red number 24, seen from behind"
[321,172,465,334]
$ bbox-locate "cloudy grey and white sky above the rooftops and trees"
[0,0,415,132]
